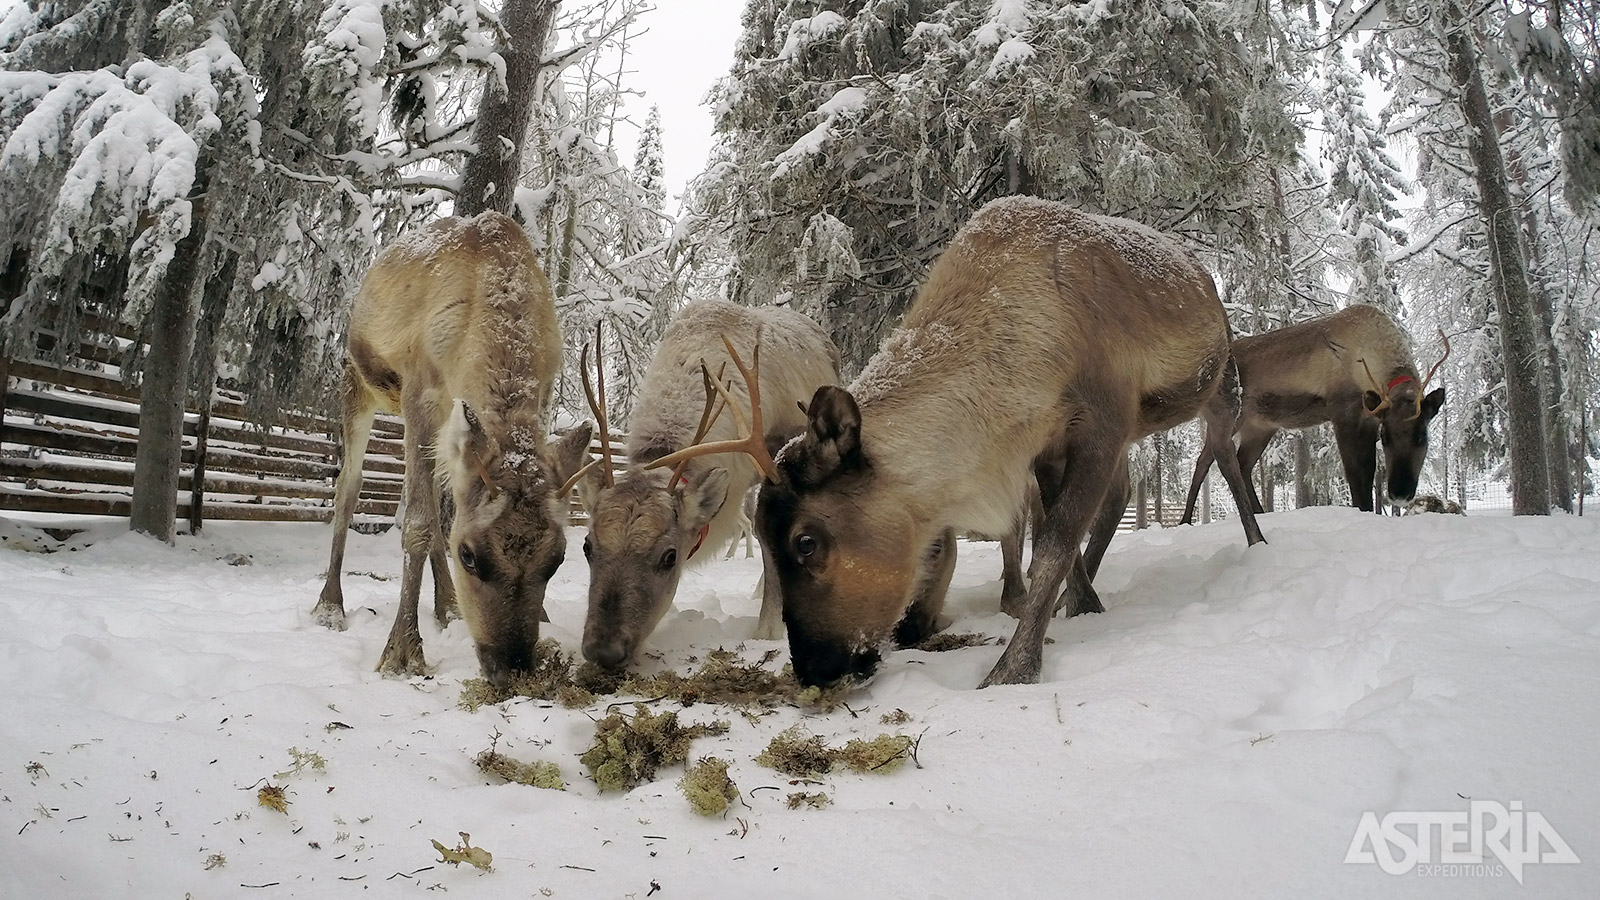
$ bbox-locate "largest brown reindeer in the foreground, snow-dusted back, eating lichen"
[649,197,1262,685]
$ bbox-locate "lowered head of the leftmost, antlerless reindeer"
[437,400,589,685]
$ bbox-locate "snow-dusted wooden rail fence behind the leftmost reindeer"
[0,341,624,528]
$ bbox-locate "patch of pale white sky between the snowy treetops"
[618,0,744,213]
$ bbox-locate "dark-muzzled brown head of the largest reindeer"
[755,386,939,685]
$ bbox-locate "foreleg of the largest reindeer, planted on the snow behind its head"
[979,407,1128,687]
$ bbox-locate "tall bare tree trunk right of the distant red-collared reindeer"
[1443,3,1550,516]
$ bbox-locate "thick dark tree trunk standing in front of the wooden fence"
[128,193,206,543]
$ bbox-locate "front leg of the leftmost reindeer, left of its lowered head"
[378,396,438,676]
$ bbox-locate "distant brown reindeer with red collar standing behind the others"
[1182,306,1450,522]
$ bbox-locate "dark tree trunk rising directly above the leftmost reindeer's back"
[456,0,562,216]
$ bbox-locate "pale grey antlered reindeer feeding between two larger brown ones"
[579,301,838,669]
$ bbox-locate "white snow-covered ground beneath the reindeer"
[0,509,1600,900]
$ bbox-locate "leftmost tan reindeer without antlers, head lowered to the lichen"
[312,213,589,684]
